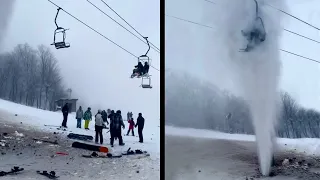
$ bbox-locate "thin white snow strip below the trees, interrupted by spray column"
[165,126,320,158]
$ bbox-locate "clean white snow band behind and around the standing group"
[0,99,160,159]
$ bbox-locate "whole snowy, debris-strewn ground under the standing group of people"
[0,100,160,180]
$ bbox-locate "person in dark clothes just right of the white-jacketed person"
[110,110,125,147]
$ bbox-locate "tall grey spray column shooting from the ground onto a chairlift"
[210,0,285,175]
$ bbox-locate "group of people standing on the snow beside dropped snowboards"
[62,103,144,147]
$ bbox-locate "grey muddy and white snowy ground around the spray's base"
[165,126,320,180]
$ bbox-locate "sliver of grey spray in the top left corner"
[0,0,15,48]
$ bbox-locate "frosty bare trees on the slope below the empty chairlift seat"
[0,43,67,111]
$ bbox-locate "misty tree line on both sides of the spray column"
[165,72,320,138]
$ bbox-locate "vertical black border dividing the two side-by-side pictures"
[160,0,165,180]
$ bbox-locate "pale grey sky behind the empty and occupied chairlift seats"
[3,0,160,119]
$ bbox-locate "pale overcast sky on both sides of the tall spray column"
[165,0,320,110]
